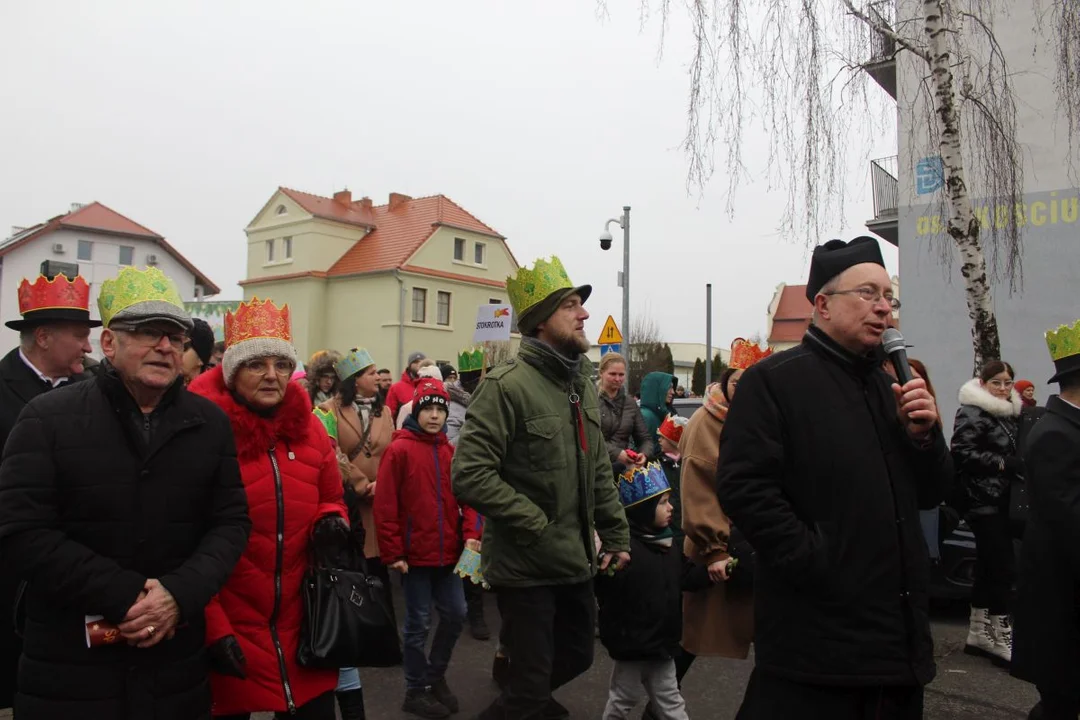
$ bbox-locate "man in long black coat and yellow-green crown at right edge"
[1012,322,1080,720]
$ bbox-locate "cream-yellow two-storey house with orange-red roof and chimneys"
[241,188,518,373]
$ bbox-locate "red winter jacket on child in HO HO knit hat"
[375,416,481,568]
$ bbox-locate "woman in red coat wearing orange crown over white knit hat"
[190,299,348,720]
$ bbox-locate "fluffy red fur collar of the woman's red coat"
[188,365,311,460]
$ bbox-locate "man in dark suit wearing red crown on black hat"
[0,275,100,708]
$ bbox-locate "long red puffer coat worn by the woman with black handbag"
[190,367,348,715]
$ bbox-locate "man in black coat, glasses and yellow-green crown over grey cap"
[0,268,251,720]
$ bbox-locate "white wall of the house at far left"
[0,229,195,357]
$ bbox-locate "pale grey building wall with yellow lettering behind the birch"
[897,0,1080,425]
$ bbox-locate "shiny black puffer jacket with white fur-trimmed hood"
[953,378,1023,511]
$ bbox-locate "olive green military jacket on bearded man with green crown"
[453,338,630,587]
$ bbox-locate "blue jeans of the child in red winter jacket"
[402,565,465,690]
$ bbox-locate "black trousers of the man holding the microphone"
[735,668,922,720]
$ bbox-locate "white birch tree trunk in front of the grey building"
[922,0,1001,375]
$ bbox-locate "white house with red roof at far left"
[0,202,221,355]
